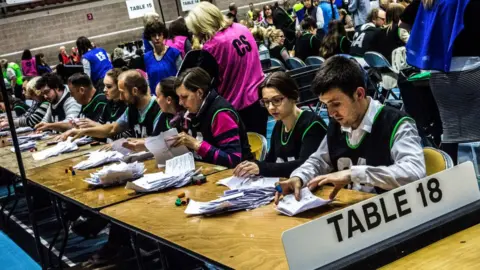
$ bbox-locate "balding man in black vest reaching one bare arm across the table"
[62,70,160,139]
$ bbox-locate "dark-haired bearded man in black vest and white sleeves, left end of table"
[35,73,81,132]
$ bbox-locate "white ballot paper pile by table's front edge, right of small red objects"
[84,162,145,186]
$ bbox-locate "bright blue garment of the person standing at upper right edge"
[407,0,473,72]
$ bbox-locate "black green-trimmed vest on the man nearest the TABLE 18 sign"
[327,106,412,193]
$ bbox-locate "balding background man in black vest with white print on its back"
[350,8,386,57]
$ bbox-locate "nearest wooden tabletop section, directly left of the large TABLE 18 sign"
[100,170,374,269]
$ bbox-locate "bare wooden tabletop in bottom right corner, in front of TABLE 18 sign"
[381,224,480,270]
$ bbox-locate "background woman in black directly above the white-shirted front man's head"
[320,20,352,59]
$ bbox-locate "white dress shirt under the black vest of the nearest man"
[291,98,426,192]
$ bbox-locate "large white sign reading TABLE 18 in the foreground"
[282,162,480,269]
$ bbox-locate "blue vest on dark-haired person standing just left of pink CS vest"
[143,47,181,95]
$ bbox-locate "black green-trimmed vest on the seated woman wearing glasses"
[270,111,327,163]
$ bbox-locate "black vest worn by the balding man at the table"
[127,98,160,138]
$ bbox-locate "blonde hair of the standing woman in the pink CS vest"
[185,2,229,40]
